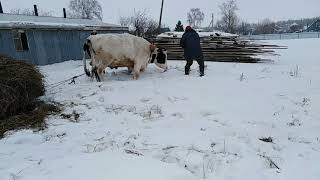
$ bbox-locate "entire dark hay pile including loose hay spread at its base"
[0,55,57,138]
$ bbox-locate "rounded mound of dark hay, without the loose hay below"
[0,56,45,119]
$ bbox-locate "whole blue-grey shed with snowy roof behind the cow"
[0,14,128,65]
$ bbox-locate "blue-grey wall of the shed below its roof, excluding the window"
[0,29,125,65]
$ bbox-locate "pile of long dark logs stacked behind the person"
[151,36,287,63]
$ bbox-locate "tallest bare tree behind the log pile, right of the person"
[217,0,239,33]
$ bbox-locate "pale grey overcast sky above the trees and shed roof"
[0,0,320,27]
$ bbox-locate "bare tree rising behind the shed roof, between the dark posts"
[69,0,102,20]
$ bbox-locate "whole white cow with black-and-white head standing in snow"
[83,33,167,81]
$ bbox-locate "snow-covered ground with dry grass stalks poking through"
[0,39,320,180]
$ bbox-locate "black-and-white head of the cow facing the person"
[149,44,168,70]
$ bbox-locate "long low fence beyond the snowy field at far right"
[241,32,320,40]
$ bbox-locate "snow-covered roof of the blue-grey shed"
[0,14,127,28]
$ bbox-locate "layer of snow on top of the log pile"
[157,31,239,38]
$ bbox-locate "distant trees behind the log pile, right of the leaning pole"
[179,0,320,35]
